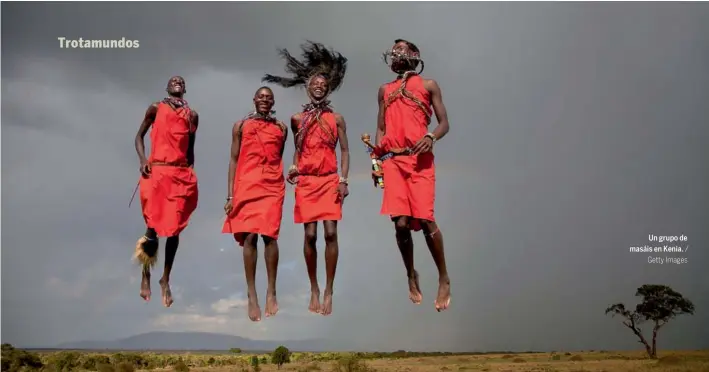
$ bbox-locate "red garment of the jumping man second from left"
[222,119,286,247]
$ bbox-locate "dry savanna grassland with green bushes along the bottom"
[2,346,709,372]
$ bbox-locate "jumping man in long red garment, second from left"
[222,87,288,322]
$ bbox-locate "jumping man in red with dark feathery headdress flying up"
[263,42,350,315]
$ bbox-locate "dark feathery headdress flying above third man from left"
[261,40,347,101]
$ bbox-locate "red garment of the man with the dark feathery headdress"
[293,111,342,223]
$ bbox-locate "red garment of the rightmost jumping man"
[380,75,436,231]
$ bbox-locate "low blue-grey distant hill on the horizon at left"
[56,332,348,351]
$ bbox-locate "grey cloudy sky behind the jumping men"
[2,3,709,350]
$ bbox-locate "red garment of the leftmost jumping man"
[140,102,199,237]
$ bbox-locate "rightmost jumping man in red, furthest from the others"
[373,39,450,311]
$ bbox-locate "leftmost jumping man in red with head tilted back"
[135,76,199,307]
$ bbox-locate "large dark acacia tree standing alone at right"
[606,284,694,359]
